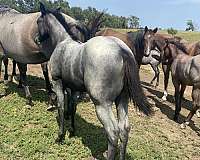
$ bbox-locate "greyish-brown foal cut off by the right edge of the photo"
[163,41,200,128]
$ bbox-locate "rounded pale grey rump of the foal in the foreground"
[83,36,131,100]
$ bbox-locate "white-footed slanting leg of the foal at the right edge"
[181,87,200,129]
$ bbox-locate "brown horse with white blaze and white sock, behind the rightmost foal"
[145,28,200,120]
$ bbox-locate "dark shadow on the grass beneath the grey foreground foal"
[63,114,133,160]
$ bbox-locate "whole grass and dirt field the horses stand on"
[0,30,200,160]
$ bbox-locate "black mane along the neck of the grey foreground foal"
[48,10,80,41]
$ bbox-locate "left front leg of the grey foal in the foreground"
[53,79,66,143]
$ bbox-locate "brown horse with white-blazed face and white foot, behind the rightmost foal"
[145,27,200,119]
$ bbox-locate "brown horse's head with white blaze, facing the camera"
[144,26,158,56]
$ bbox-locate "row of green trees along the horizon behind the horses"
[0,0,139,28]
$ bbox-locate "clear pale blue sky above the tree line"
[68,0,200,30]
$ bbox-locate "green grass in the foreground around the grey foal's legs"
[0,77,199,160]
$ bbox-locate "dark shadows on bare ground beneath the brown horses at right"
[142,82,200,134]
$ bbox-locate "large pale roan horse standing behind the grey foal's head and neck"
[0,5,104,106]
